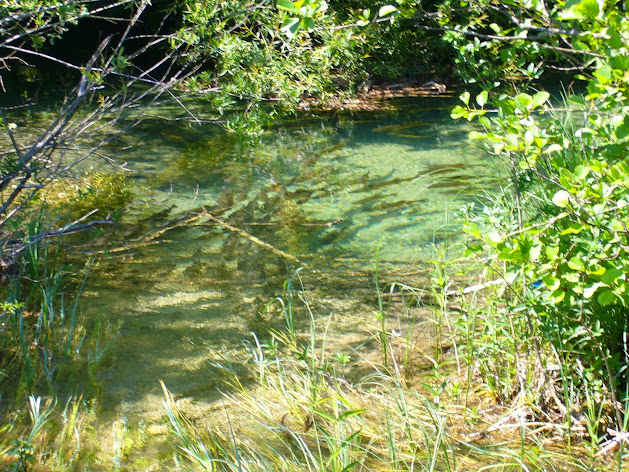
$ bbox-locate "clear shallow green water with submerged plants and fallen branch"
[72,98,497,468]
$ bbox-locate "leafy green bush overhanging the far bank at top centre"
[177,0,366,131]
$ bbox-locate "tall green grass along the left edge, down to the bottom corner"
[0,234,109,472]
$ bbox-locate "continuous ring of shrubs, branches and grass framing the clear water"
[0,0,629,472]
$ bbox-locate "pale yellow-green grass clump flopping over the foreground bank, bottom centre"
[162,272,587,472]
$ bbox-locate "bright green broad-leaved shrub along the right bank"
[452,0,629,432]
